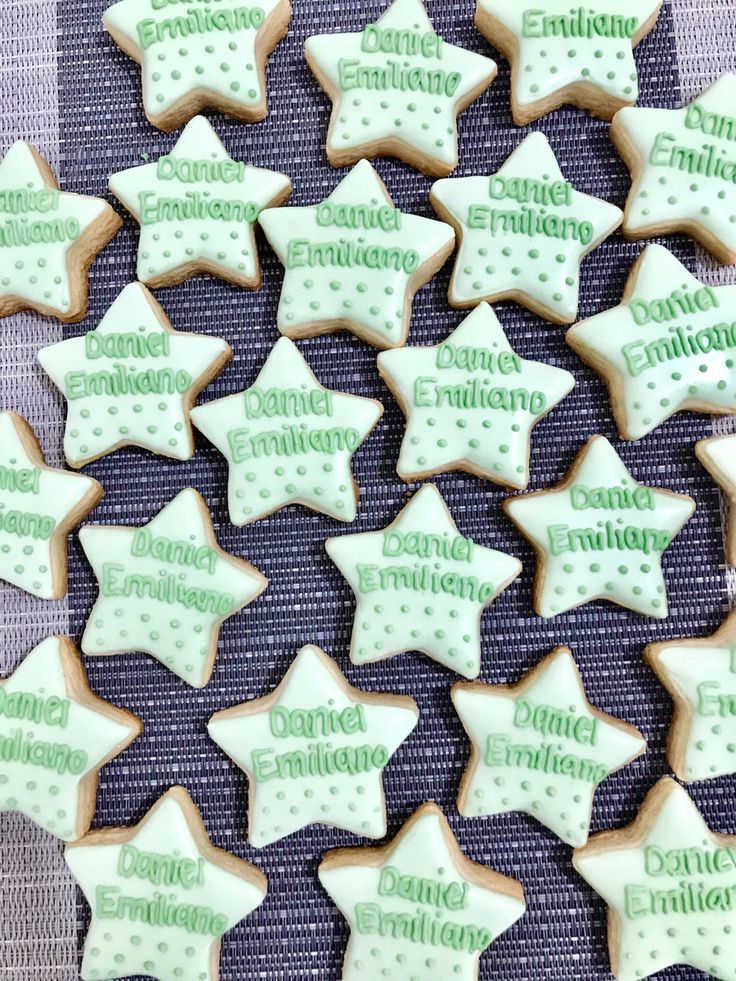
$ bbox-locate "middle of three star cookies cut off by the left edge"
[0,412,104,599]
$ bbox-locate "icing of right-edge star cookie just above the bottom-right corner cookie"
[657,641,736,780]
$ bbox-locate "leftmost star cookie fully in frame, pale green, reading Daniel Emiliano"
[38,283,232,467]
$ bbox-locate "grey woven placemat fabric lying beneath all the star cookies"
[0,0,736,981]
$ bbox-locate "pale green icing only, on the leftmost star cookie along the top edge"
[103,0,282,123]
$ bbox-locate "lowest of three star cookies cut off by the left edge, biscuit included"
[0,637,143,840]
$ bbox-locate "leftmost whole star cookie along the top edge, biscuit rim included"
[102,0,291,132]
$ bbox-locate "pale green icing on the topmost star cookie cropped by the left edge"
[0,140,107,315]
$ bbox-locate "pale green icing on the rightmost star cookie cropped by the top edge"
[478,0,661,106]
